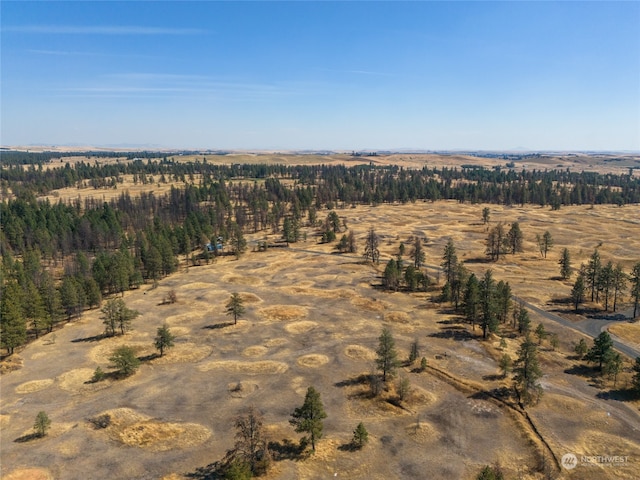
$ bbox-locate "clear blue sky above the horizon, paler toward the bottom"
[0,0,640,151]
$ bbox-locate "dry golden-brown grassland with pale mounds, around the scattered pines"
[0,154,640,480]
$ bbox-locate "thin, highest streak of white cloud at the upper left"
[2,25,208,35]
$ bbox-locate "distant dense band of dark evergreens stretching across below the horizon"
[2,157,640,208]
